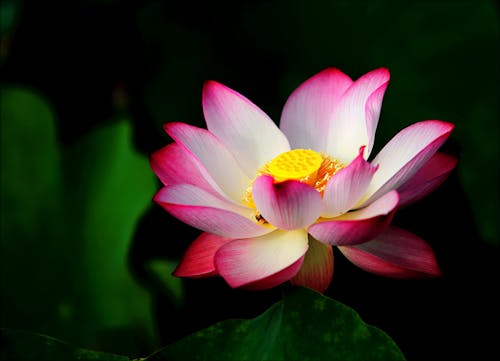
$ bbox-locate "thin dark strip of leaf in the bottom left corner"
[0,329,130,361]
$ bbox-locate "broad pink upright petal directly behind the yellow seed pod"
[280,68,352,152]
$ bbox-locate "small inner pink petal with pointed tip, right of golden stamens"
[321,147,377,218]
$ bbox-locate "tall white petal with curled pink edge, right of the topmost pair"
[327,68,390,163]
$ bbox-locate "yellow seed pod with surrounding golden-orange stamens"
[243,149,345,223]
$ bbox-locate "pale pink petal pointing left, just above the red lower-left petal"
[154,184,274,238]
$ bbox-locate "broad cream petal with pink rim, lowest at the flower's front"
[215,229,308,289]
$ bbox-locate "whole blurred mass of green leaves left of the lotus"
[0,87,159,352]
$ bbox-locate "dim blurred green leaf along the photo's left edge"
[0,86,68,335]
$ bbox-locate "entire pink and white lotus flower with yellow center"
[150,68,456,292]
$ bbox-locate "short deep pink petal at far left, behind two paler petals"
[149,143,213,192]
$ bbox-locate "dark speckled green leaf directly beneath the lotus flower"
[146,287,405,361]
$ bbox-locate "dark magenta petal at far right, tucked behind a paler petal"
[398,152,458,208]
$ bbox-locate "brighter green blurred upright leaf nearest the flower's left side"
[64,119,157,354]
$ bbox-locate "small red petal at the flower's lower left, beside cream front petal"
[173,233,232,278]
